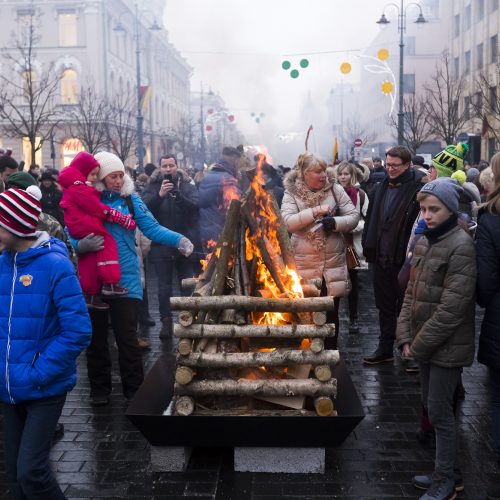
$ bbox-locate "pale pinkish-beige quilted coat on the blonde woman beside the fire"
[281,170,359,297]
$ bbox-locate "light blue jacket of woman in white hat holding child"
[96,175,183,299]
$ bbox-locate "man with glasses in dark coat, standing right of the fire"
[362,146,427,365]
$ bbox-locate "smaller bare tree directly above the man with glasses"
[389,94,432,154]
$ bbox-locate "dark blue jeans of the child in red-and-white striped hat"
[3,394,66,500]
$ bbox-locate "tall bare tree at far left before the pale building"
[0,7,62,164]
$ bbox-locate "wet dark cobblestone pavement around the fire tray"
[0,272,494,500]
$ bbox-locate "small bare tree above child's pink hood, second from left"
[68,82,111,154]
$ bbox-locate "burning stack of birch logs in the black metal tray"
[170,189,339,416]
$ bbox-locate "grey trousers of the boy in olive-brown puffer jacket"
[419,363,462,479]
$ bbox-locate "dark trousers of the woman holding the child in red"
[87,298,144,398]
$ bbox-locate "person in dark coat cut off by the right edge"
[476,153,500,498]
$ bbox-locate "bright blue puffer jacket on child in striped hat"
[0,232,92,404]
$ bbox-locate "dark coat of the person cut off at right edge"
[476,212,500,371]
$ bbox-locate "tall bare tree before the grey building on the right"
[425,51,469,144]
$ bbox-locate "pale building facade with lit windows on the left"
[0,0,191,168]
